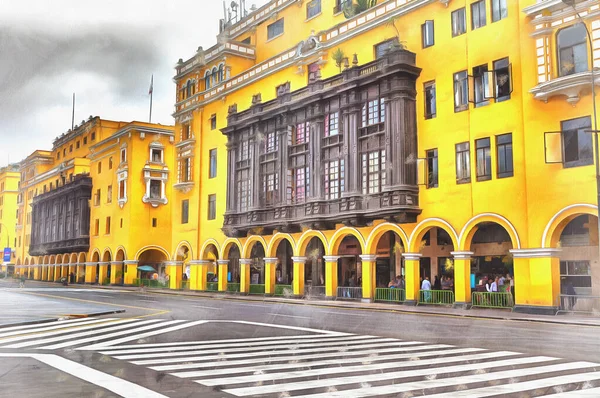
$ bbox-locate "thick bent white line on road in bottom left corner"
[0,354,167,398]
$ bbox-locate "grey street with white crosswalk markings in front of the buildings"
[0,284,600,397]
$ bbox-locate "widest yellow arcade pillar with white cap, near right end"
[510,248,560,315]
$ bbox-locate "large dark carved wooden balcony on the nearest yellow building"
[223,51,421,236]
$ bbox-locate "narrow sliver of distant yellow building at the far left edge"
[0,164,21,272]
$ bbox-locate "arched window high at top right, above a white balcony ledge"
[556,24,588,76]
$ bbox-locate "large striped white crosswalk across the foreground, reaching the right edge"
[94,333,600,398]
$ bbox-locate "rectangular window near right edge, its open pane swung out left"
[561,116,594,167]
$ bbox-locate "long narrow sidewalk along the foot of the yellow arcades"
[8,281,600,327]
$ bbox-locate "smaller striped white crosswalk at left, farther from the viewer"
[0,318,205,350]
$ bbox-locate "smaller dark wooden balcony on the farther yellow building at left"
[29,175,92,256]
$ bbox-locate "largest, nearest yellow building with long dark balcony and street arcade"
[169,0,600,312]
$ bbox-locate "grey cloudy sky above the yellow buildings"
[0,0,267,166]
